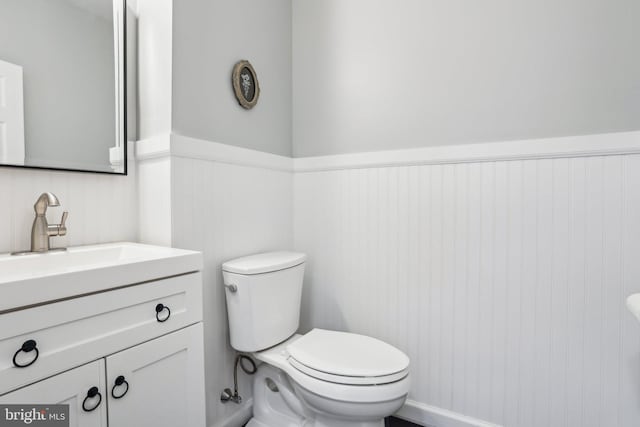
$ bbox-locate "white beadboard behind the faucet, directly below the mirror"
[0,150,138,253]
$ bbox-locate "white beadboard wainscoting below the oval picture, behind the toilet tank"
[138,135,293,427]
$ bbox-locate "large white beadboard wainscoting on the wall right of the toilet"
[294,133,640,427]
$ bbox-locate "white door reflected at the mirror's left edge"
[0,60,24,165]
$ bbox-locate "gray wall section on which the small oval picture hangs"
[172,0,292,155]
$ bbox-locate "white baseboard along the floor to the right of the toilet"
[394,400,501,427]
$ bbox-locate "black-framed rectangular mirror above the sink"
[0,0,127,175]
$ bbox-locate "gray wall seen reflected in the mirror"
[0,0,115,170]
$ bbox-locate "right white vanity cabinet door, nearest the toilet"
[107,323,205,427]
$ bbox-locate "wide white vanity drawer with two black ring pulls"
[0,273,202,395]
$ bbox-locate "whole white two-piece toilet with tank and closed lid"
[222,252,409,427]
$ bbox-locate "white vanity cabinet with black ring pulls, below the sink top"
[0,272,205,427]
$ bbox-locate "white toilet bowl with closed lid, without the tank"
[249,329,410,427]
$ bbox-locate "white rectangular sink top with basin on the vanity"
[0,242,202,313]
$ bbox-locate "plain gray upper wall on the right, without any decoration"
[293,0,640,157]
